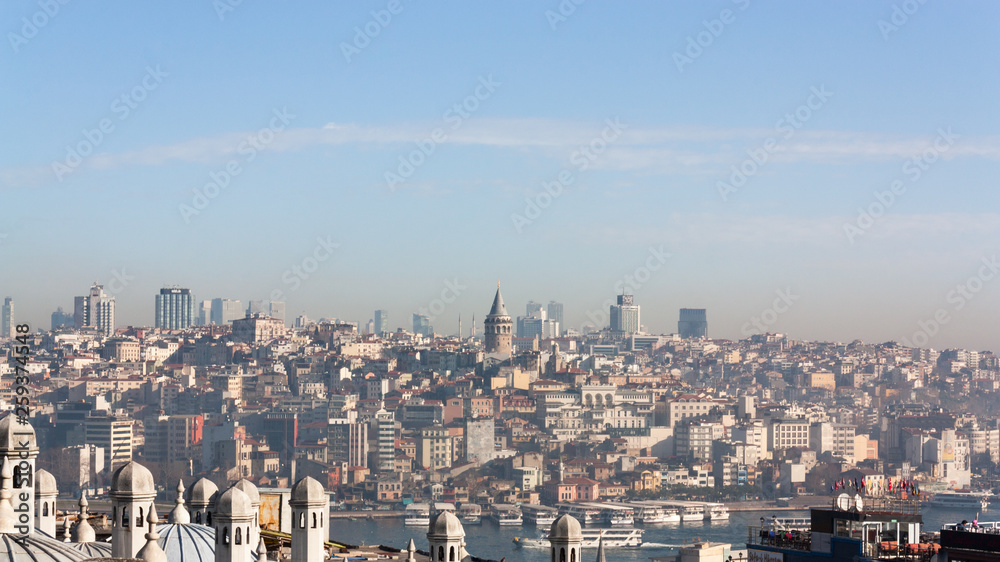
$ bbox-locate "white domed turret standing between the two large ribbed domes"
[109,461,156,558]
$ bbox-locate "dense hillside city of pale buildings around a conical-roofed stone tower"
[0,284,1000,560]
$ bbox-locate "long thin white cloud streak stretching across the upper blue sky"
[0,118,1000,187]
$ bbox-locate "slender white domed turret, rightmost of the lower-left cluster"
[288,476,330,562]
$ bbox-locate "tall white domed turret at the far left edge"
[0,414,38,535]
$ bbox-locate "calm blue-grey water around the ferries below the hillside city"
[330,504,1000,562]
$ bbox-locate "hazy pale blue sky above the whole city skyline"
[0,0,1000,349]
